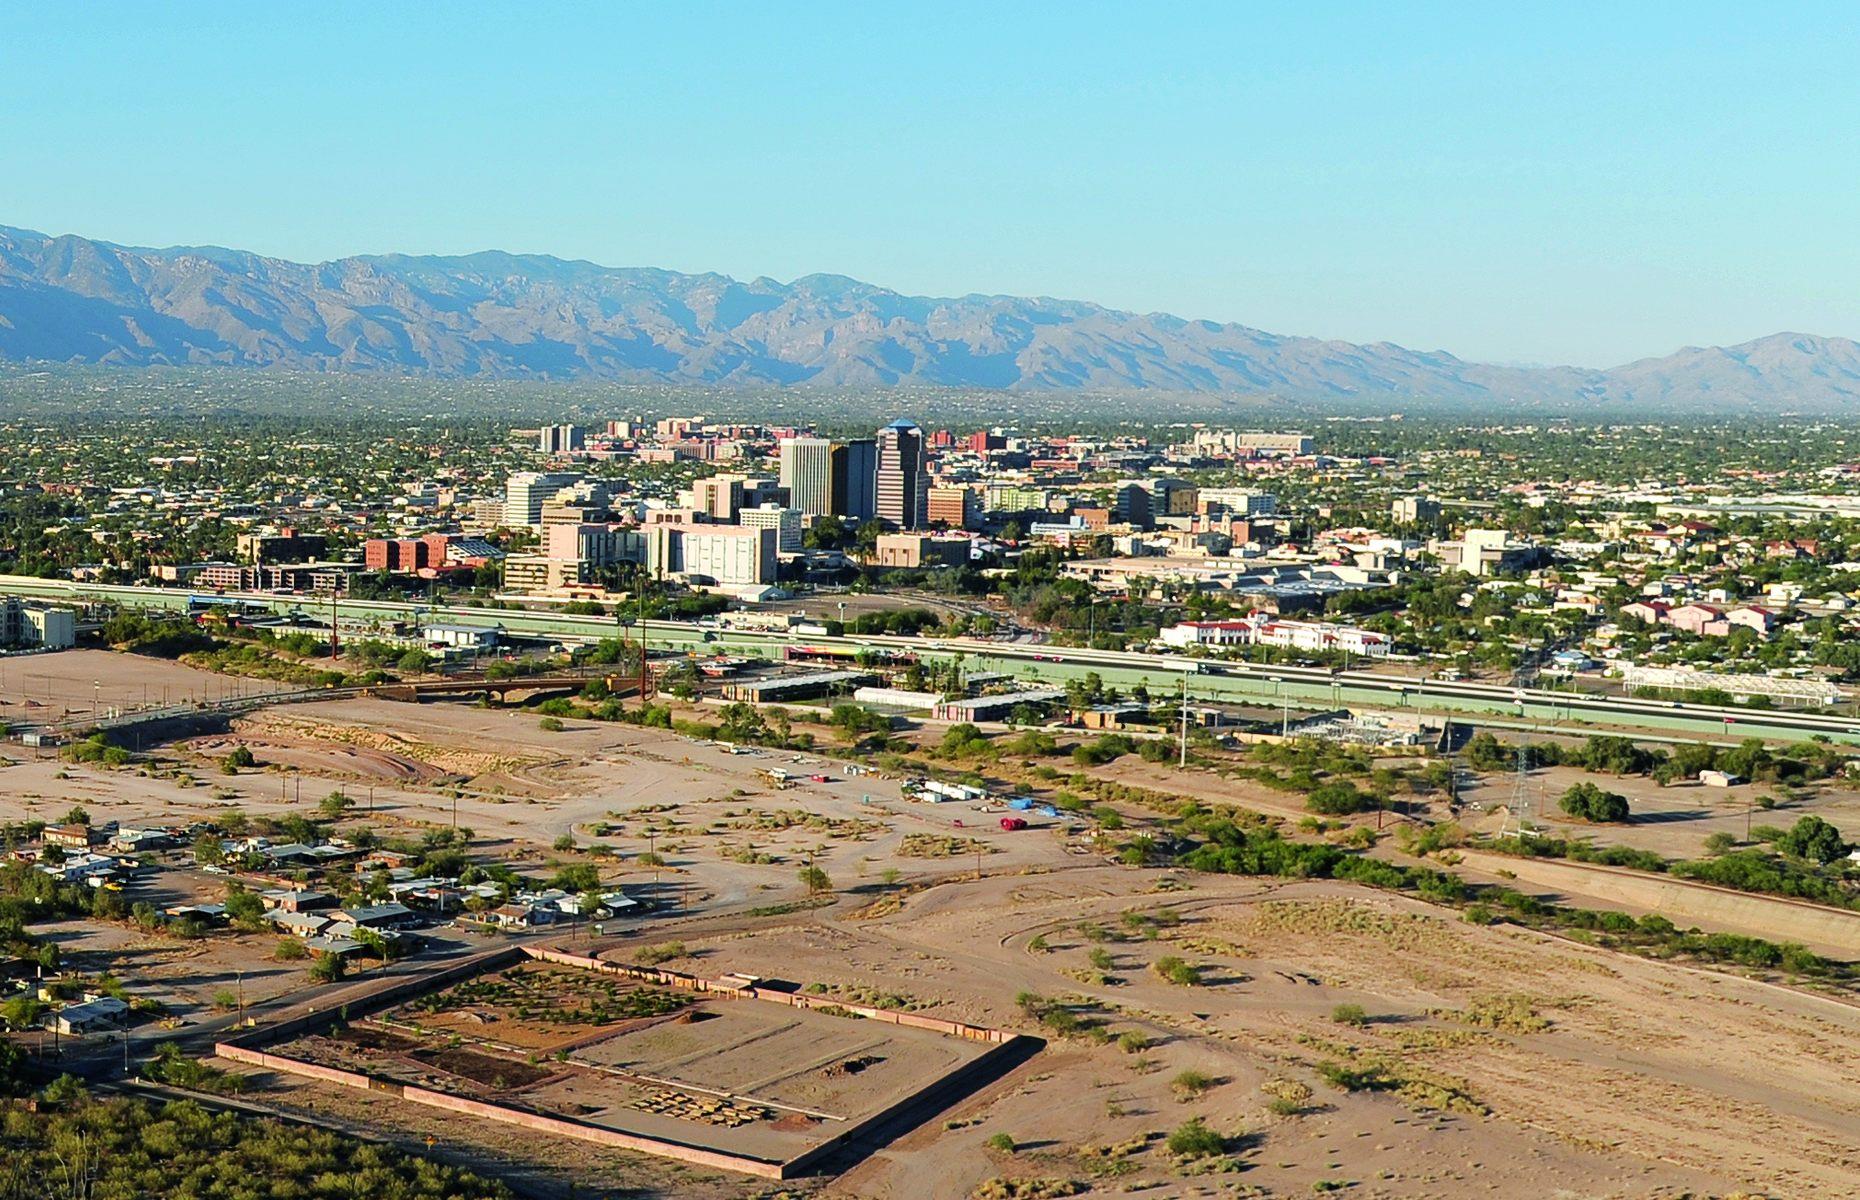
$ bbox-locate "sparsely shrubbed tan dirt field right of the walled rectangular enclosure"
[694,869,1860,1196]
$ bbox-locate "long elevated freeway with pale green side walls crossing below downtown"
[0,575,1860,744]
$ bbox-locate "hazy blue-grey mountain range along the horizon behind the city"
[0,227,1860,409]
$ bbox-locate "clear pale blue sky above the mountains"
[0,0,1860,367]
